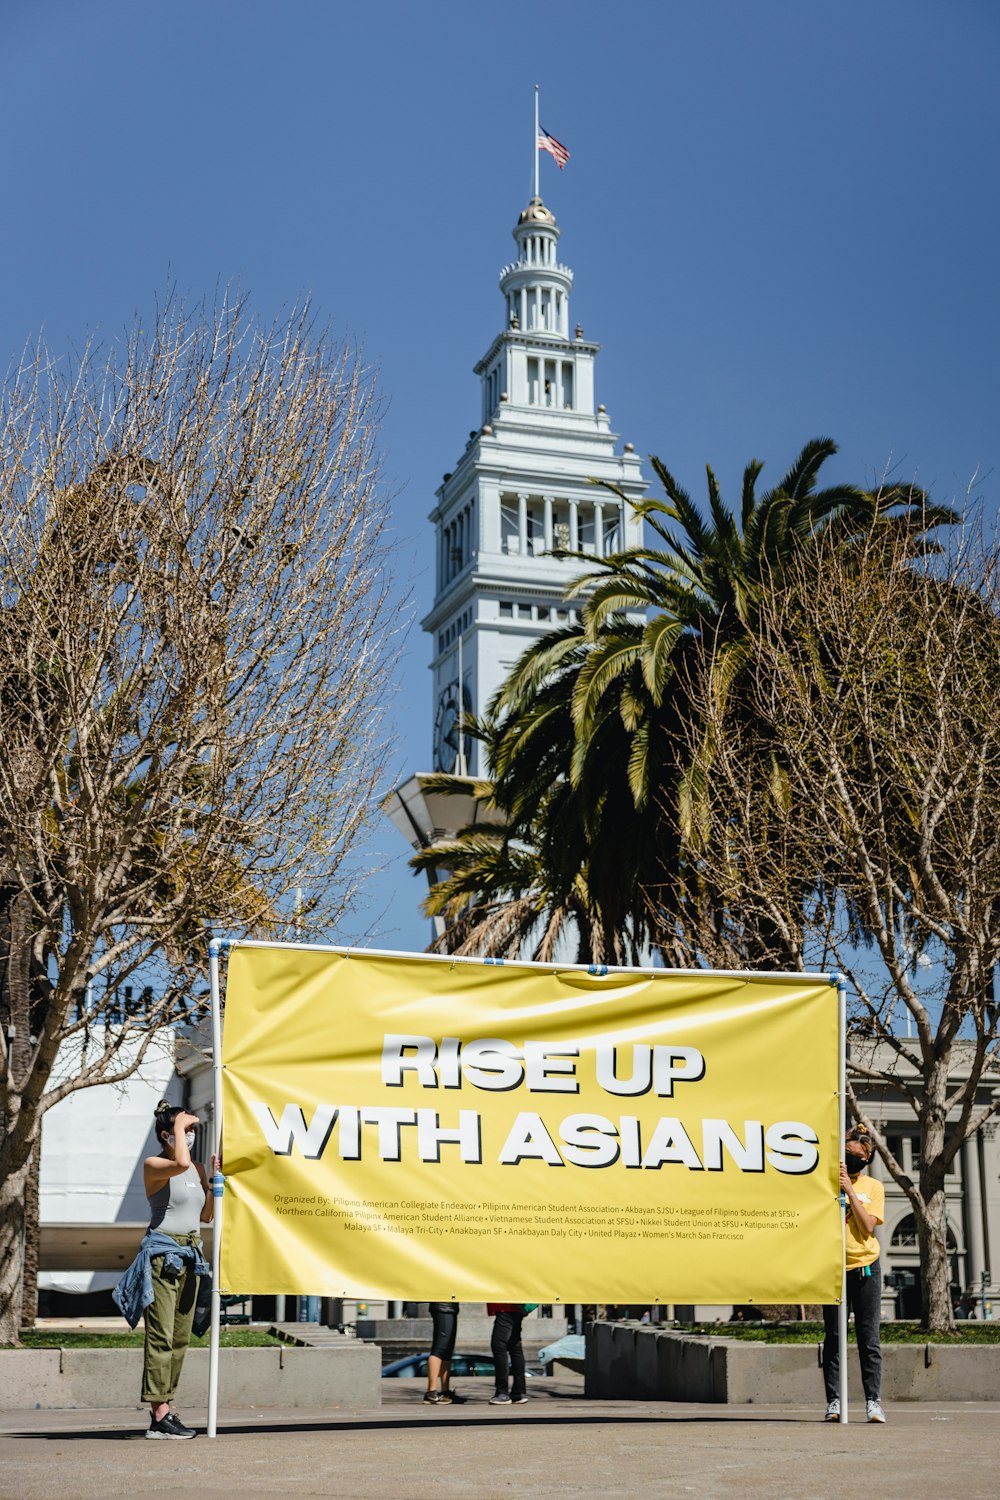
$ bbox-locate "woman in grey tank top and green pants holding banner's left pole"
[142,1100,214,1439]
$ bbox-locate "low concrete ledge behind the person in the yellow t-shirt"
[585,1323,1000,1406]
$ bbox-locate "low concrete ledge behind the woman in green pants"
[0,1340,382,1412]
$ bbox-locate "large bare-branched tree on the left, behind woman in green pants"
[0,297,396,1343]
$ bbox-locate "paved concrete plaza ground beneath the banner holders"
[0,1377,1000,1500]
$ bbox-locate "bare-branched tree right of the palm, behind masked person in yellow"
[664,527,1000,1331]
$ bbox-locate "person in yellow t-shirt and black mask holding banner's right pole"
[823,1125,886,1422]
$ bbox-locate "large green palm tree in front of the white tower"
[419,438,957,960]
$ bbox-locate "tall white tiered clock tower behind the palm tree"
[423,198,646,776]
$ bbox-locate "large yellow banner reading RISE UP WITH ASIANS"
[222,945,843,1304]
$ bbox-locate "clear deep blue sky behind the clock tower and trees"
[0,0,1000,948]
